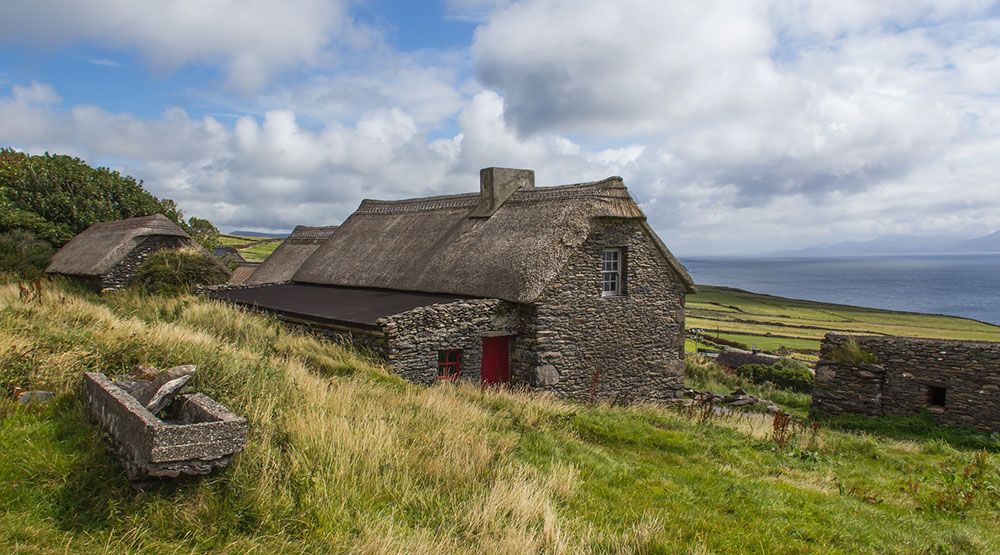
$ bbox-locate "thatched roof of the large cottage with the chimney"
[292,177,693,302]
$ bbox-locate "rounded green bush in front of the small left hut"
[130,248,229,293]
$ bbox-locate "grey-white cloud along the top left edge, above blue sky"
[0,0,366,91]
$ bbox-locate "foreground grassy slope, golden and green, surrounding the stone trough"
[0,285,1000,553]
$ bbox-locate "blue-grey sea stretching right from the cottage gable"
[681,253,1000,325]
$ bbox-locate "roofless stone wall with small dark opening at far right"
[812,334,1000,431]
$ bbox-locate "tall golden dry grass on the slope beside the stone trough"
[0,285,600,553]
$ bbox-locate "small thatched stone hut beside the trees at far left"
[45,214,228,291]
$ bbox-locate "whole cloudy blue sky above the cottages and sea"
[0,0,1000,255]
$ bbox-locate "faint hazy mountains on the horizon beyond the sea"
[768,230,1000,256]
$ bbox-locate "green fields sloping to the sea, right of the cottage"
[686,286,1000,358]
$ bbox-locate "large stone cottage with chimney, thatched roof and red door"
[211,168,694,402]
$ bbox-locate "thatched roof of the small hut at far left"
[46,214,190,277]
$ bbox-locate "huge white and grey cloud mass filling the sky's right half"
[472,0,1000,252]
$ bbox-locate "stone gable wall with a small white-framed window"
[513,220,684,403]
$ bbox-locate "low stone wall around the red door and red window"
[378,299,520,384]
